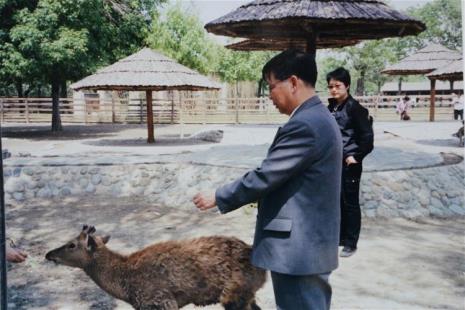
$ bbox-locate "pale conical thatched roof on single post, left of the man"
[71,48,221,91]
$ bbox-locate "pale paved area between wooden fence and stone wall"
[3,122,464,171]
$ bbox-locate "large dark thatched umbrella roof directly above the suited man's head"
[205,0,425,48]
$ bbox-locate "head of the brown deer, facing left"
[45,225,110,268]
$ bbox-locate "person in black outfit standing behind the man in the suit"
[326,68,373,257]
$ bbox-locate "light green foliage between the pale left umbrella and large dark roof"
[147,2,273,82]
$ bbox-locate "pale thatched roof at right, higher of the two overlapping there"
[381,44,462,75]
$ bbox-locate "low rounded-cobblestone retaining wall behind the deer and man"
[4,163,465,218]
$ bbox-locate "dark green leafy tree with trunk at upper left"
[0,0,161,131]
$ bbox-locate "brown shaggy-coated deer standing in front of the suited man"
[45,225,266,309]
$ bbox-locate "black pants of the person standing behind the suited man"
[339,163,362,249]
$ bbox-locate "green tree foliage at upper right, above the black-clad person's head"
[318,0,462,95]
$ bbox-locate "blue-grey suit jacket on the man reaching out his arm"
[216,96,342,275]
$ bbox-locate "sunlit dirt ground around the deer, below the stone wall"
[6,197,465,310]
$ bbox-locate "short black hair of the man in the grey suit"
[262,49,318,87]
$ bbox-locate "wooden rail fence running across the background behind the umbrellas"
[0,95,453,124]
